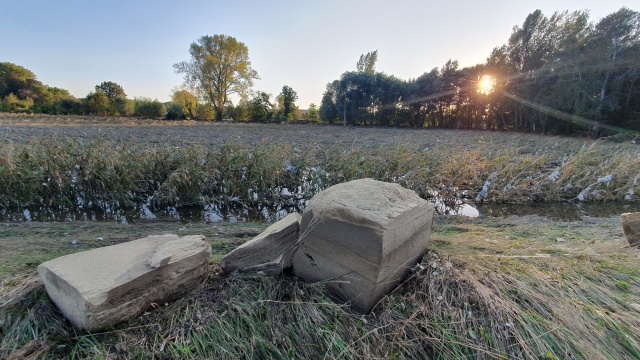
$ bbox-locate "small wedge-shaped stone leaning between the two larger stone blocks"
[220,213,301,276]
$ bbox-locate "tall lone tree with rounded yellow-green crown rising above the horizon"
[173,35,259,121]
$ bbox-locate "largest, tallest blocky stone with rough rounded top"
[293,179,434,312]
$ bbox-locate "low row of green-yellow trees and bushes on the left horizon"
[0,57,310,122]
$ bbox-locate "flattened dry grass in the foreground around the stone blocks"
[0,216,640,359]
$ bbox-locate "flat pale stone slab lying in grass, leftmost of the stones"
[38,234,211,331]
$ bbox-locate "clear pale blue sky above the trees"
[0,0,640,109]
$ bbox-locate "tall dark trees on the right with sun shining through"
[320,7,640,135]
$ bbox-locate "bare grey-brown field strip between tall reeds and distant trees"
[0,113,608,157]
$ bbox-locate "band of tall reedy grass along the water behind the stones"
[0,138,640,215]
